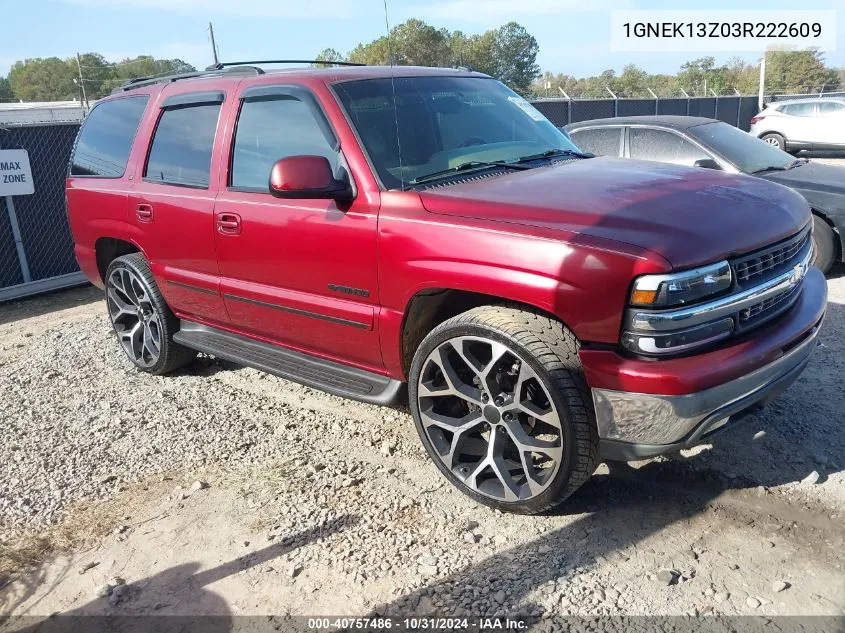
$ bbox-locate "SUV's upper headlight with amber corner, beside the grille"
[630,262,732,308]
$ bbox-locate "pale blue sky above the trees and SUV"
[0,0,845,77]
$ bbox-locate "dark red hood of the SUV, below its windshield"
[420,158,810,269]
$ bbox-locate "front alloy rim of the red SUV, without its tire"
[417,336,564,502]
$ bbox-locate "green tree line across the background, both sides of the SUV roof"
[0,19,845,102]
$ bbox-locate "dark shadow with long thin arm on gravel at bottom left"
[0,515,358,633]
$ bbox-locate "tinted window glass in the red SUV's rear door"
[144,103,220,187]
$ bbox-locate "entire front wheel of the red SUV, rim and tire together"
[409,306,598,514]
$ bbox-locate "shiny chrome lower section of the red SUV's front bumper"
[592,269,827,460]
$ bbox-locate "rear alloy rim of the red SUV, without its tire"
[106,267,161,367]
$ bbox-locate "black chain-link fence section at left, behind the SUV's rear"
[0,123,84,301]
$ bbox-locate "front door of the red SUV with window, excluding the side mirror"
[214,85,383,368]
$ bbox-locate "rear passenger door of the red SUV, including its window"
[129,82,229,323]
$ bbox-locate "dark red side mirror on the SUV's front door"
[270,156,353,201]
